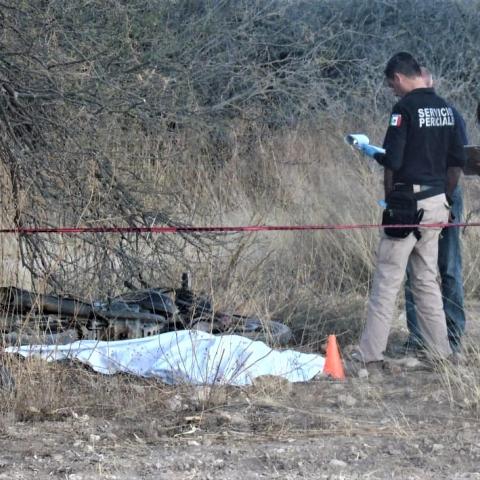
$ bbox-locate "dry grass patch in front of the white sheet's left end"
[2,356,172,421]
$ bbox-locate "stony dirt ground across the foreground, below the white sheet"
[0,316,480,480]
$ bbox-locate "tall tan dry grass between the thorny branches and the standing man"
[3,120,479,348]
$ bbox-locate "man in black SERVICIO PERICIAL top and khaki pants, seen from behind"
[357,52,465,362]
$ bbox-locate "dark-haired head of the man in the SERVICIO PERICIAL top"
[385,52,425,97]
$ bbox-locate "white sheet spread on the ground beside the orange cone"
[6,330,325,385]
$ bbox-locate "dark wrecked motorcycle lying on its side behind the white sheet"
[0,274,292,346]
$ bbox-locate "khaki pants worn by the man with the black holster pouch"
[359,194,452,362]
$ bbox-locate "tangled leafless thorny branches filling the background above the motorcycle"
[0,0,480,291]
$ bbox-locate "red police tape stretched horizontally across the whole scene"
[0,222,480,235]
